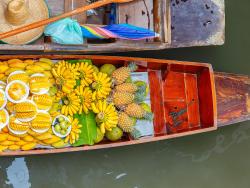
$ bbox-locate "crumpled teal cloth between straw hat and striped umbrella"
[44,18,83,45]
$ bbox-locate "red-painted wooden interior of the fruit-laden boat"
[0,55,217,143]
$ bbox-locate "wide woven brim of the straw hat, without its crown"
[0,0,49,45]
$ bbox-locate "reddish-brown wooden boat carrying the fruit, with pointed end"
[0,55,247,156]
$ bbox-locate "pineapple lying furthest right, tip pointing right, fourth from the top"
[125,103,153,120]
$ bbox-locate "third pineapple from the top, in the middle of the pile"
[113,92,135,106]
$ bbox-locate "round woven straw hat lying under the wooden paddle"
[0,0,49,44]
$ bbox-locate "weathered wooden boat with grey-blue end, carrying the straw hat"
[0,0,225,54]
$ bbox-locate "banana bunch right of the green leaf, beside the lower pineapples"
[91,100,118,134]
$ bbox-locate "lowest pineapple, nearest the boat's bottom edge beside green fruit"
[118,112,136,133]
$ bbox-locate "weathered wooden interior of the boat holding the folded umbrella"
[1,0,171,52]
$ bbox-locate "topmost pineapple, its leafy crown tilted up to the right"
[112,63,137,85]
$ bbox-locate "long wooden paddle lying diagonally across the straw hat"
[0,0,133,39]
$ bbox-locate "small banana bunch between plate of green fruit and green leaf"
[64,119,82,145]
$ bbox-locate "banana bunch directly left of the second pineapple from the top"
[92,72,111,101]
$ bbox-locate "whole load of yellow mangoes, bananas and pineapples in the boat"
[0,58,153,152]
